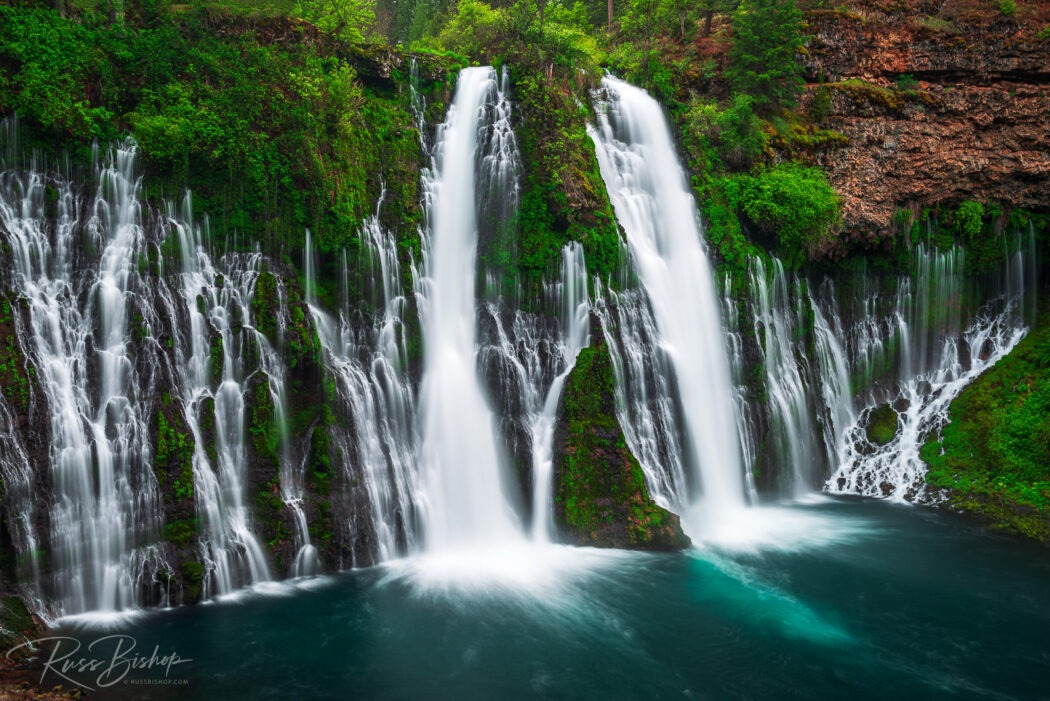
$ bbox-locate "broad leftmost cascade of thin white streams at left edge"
[0,142,167,614]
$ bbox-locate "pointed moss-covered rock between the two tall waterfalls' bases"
[553,325,690,550]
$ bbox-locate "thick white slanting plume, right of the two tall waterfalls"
[591,78,746,521]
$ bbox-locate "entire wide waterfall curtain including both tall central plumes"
[0,67,1036,618]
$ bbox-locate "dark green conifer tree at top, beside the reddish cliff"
[726,0,804,109]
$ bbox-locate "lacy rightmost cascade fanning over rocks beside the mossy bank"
[825,238,1037,501]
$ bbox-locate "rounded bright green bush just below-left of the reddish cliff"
[722,164,842,265]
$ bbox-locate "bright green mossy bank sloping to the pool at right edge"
[921,304,1050,541]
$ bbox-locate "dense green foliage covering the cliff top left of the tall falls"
[0,0,439,262]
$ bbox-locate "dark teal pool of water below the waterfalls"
[53,500,1050,701]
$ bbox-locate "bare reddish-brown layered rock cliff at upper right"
[803,2,1050,241]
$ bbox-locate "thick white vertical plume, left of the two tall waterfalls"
[417,68,522,550]
